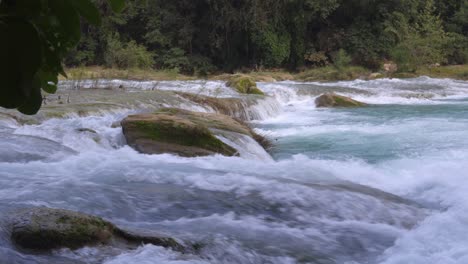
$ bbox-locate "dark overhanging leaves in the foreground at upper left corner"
[0,0,124,115]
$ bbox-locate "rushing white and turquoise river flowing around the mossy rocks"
[0,77,468,264]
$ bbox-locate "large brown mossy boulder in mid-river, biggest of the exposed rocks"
[121,108,260,157]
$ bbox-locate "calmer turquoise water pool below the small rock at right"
[264,100,468,163]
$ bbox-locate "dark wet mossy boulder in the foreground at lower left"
[10,207,183,250]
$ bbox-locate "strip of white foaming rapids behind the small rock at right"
[259,77,468,104]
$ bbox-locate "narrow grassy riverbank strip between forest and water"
[66,65,468,82]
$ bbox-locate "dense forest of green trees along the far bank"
[66,0,468,74]
